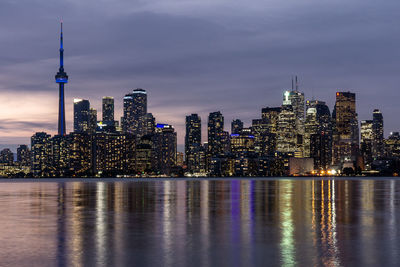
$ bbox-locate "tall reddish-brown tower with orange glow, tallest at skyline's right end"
[332,92,359,168]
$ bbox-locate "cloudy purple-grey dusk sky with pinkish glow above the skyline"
[0,0,400,151]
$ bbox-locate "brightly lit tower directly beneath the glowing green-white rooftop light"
[276,104,297,155]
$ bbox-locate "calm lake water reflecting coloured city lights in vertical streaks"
[0,178,400,266]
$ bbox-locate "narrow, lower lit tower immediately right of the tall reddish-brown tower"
[360,120,374,170]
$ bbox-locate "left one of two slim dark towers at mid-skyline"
[185,114,201,172]
